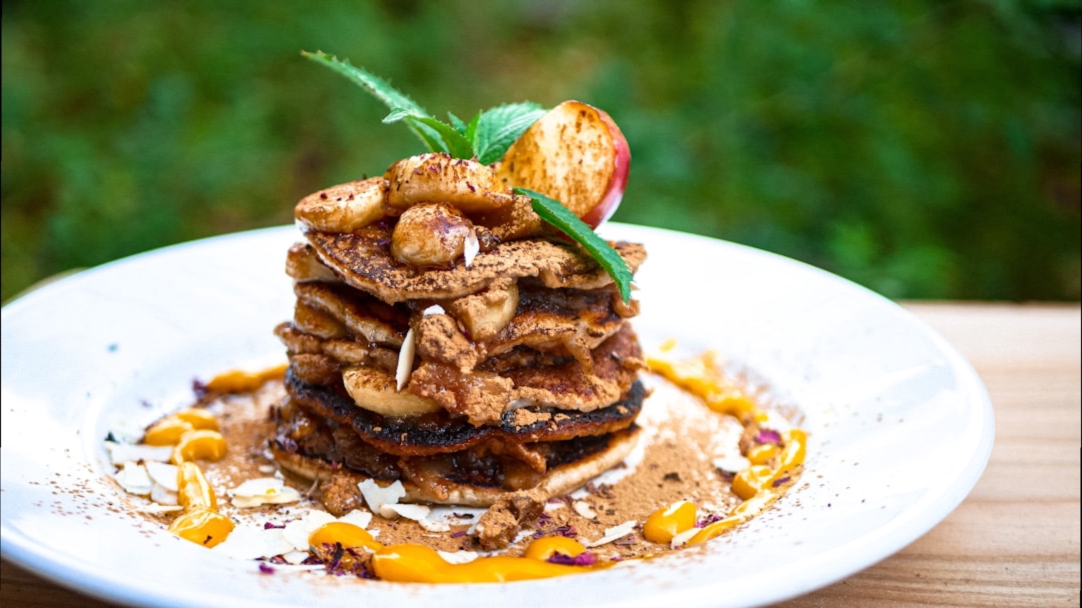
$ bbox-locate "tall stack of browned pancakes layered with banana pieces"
[271,153,645,506]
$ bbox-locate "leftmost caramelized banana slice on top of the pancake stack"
[293,177,388,233]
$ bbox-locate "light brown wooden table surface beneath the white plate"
[0,303,1082,607]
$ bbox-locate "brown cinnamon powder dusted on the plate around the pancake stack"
[135,375,783,559]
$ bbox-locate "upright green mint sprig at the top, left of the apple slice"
[301,51,546,164]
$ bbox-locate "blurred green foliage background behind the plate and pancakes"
[0,0,1082,300]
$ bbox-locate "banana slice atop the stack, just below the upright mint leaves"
[386,154,514,213]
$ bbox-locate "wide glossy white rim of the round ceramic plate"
[0,224,993,608]
